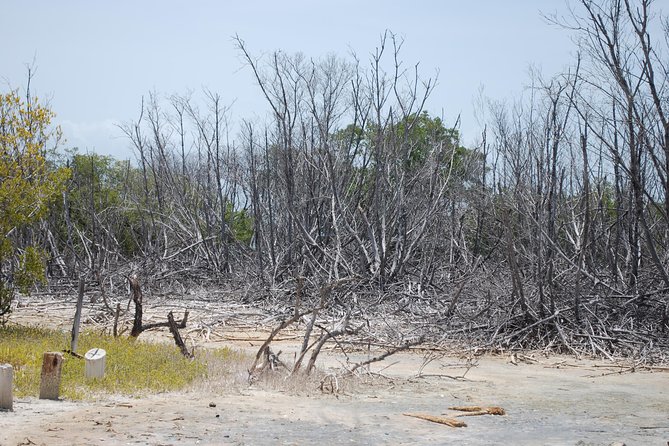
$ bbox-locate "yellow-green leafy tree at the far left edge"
[0,91,69,316]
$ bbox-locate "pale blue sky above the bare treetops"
[0,0,574,157]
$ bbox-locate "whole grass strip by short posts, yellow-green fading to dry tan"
[0,324,357,400]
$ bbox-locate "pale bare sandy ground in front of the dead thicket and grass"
[0,294,669,446]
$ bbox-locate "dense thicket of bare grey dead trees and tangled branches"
[6,0,669,354]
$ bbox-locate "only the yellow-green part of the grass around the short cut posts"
[0,325,214,399]
